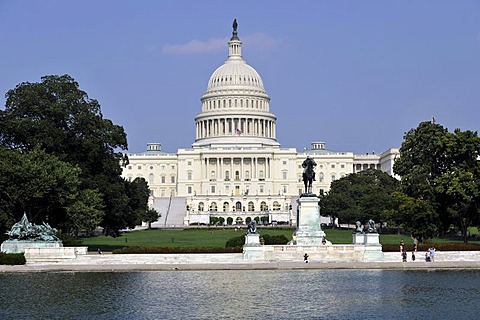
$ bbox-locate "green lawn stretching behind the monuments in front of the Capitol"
[82,227,480,251]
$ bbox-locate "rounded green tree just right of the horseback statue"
[320,169,399,223]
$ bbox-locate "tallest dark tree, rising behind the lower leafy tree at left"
[0,75,148,234]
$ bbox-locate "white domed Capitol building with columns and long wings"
[122,21,398,227]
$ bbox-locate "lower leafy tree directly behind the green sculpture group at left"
[0,147,80,234]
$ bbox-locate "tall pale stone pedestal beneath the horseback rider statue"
[295,194,325,245]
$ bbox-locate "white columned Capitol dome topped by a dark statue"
[193,20,279,148]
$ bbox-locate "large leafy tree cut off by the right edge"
[393,122,480,241]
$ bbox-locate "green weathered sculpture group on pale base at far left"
[1,213,63,253]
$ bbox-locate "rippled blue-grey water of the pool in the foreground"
[0,270,480,319]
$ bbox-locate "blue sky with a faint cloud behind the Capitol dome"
[0,0,480,154]
